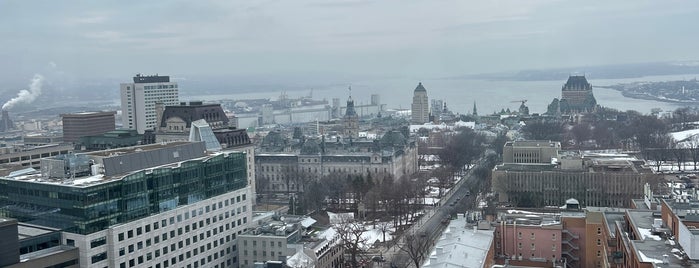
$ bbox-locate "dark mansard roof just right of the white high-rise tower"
[160,102,228,127]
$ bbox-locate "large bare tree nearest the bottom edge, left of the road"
[333,214,367,267]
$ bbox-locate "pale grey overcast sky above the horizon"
[0,0,699,83]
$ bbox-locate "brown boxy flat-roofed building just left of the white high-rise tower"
[61,112,116,142]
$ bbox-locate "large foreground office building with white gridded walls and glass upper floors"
[0,142,254,268]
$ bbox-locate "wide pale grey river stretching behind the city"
[185,75,699,114]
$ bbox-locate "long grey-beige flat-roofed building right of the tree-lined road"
[493,150,657,207]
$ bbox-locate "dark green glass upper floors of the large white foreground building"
[0,152,248,235]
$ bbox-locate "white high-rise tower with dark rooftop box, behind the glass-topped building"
[121,74,179,134]
